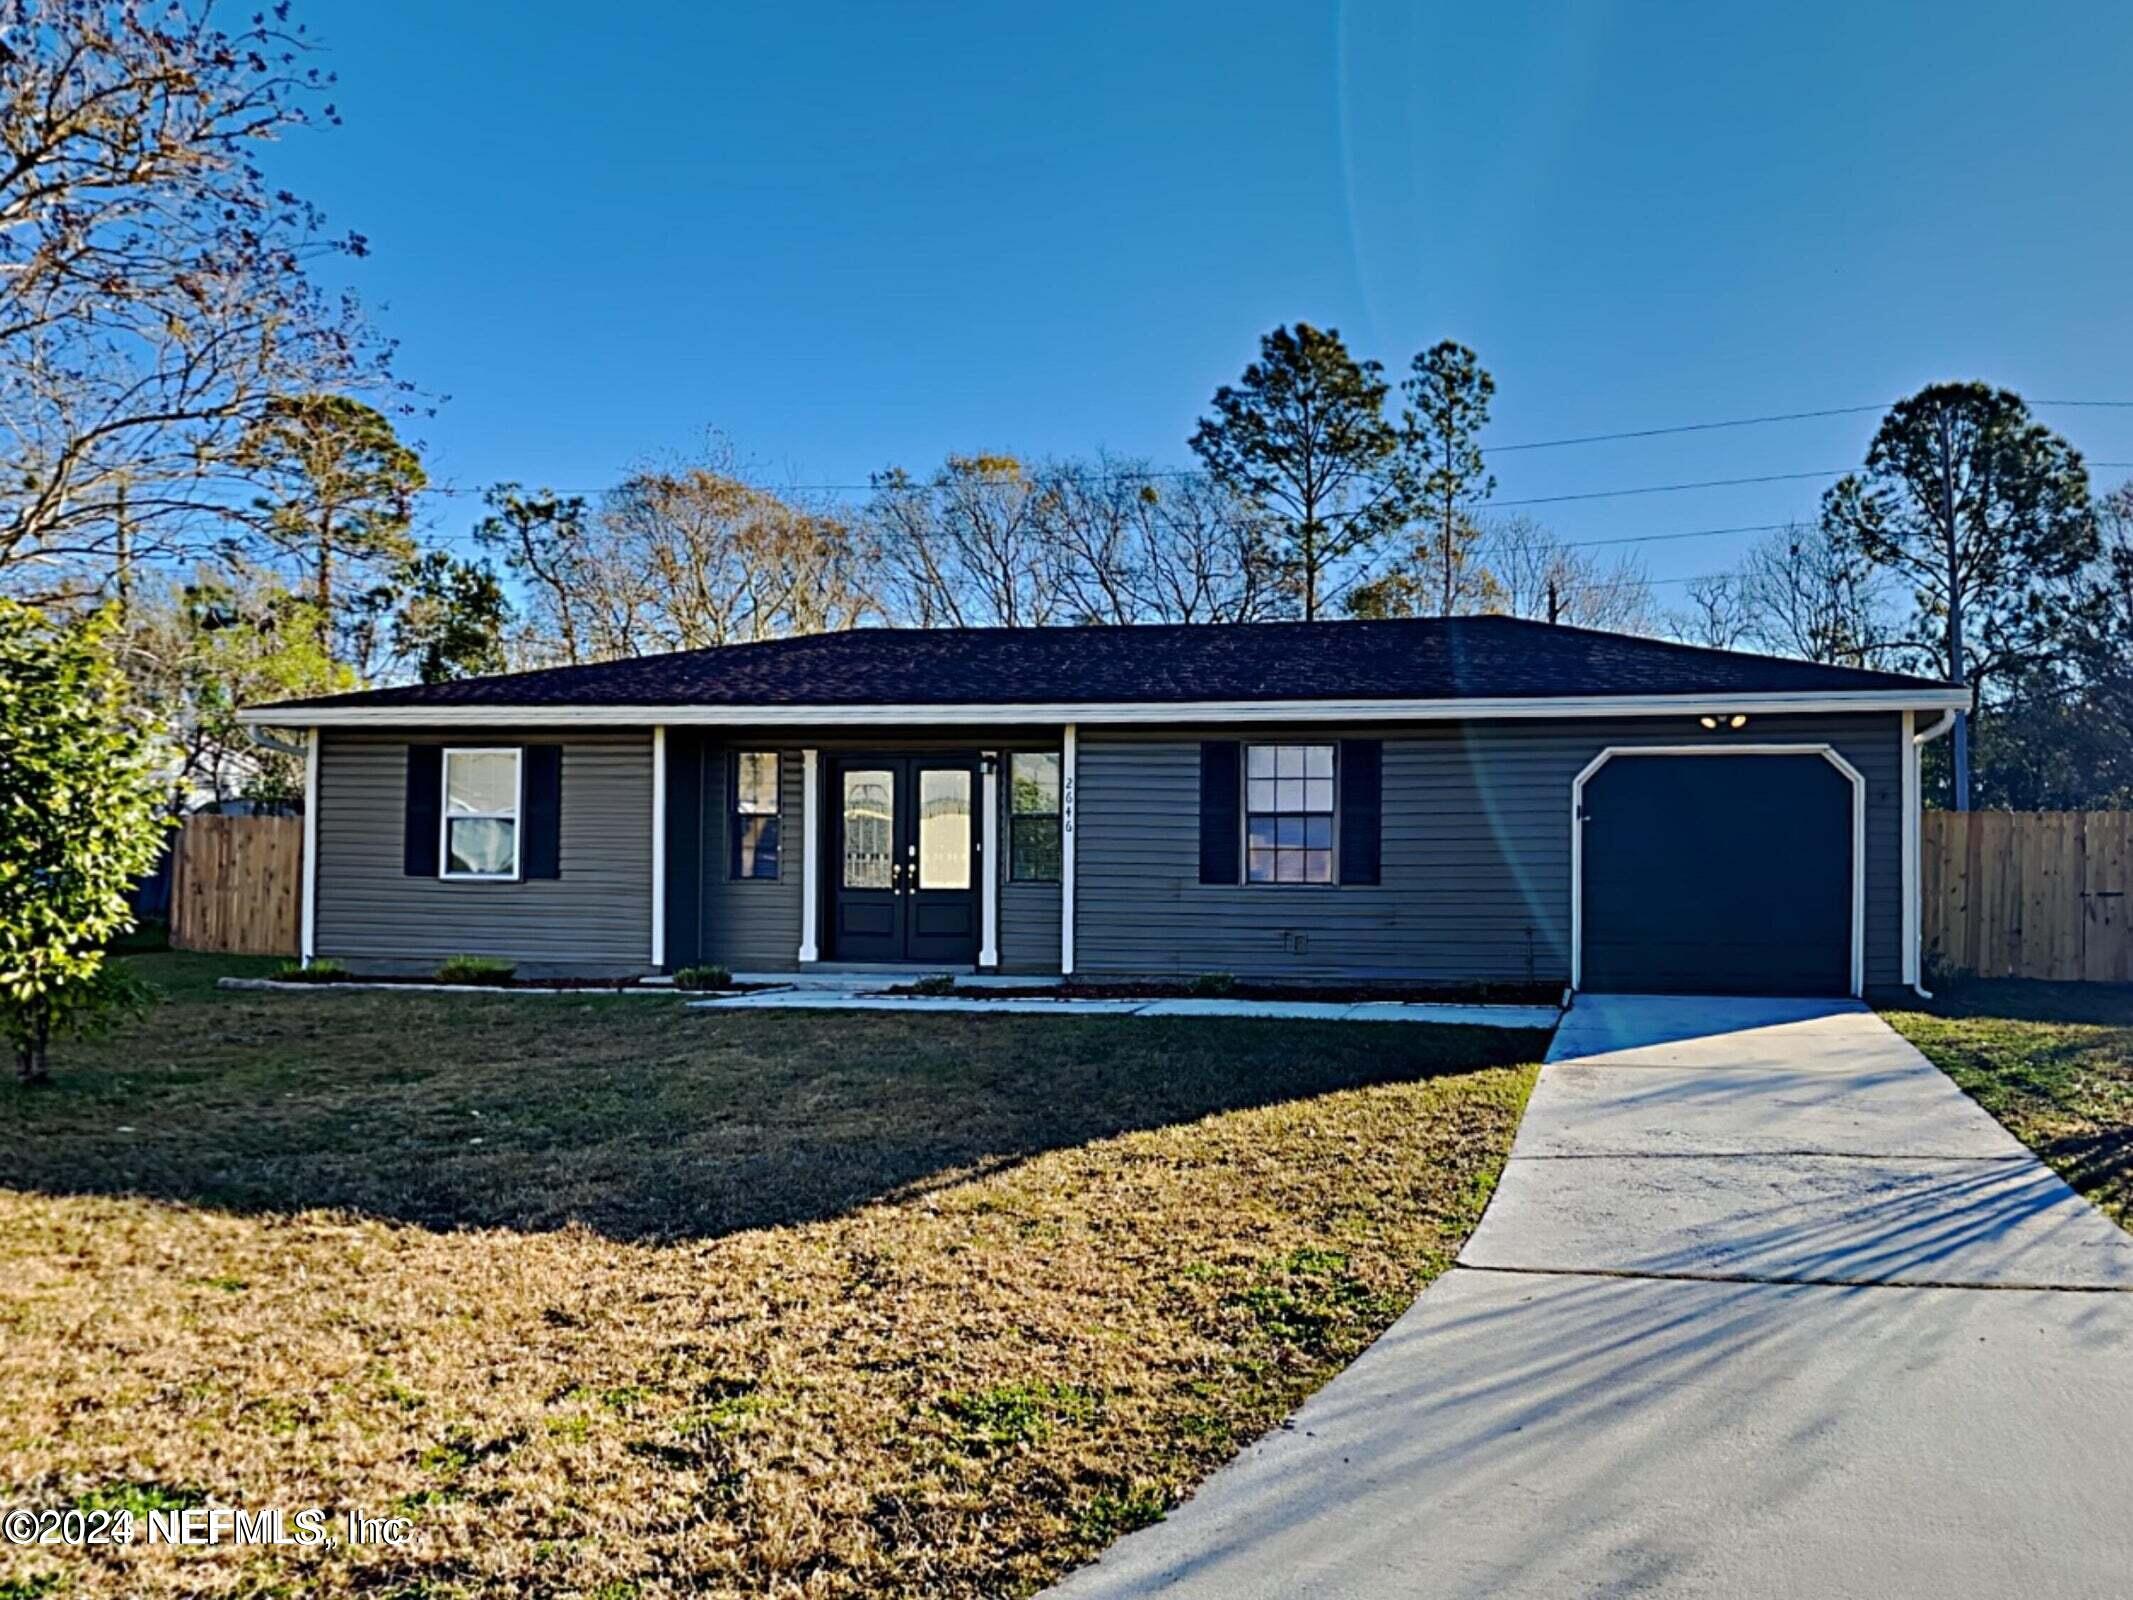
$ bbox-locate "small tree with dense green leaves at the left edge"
[0,599,166,1084]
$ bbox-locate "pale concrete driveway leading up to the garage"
[1058,996,2133,1600]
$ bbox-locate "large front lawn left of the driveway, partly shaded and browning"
[0,960,1542,1598]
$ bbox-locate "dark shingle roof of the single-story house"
[258,617,1945,710]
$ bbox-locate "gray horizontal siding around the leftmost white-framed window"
[316,727,653,971]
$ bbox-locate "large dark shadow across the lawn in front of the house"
[0,956,1546,1239]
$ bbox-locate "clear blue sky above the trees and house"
[275,0,2133,595]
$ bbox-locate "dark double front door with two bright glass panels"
[828,755,979,966]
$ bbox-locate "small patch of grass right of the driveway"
[1888,979,2133,1227]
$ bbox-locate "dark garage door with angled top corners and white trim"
[1583,755,1851,994]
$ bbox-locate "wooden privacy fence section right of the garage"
[1920,811,2133,983]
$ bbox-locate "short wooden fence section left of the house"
[171,817,303,956]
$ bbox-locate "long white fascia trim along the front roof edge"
[237,689,1969,727]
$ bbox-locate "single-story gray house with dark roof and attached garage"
[233,617,1967,994]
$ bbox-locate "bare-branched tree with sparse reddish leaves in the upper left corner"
[0,0,390,595]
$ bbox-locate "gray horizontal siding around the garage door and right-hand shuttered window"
[1075,715,1903,988]
